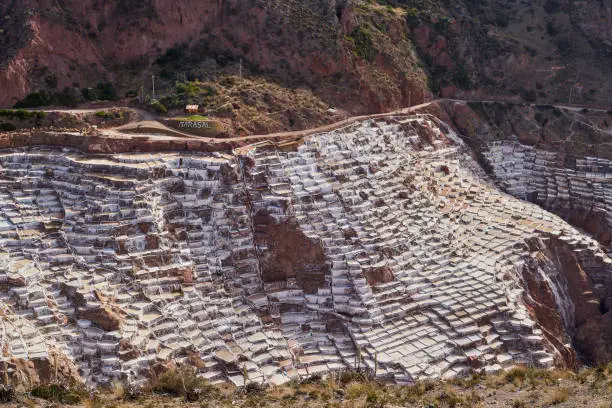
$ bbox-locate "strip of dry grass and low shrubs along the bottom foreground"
[0,364,612,408]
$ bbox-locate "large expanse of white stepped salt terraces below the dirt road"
[0,116,611,385]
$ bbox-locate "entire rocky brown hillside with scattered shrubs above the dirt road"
[0,0,612,132]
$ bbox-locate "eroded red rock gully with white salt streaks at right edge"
[522,237,612,367]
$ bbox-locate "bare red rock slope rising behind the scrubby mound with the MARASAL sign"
[0,0,428,113]
